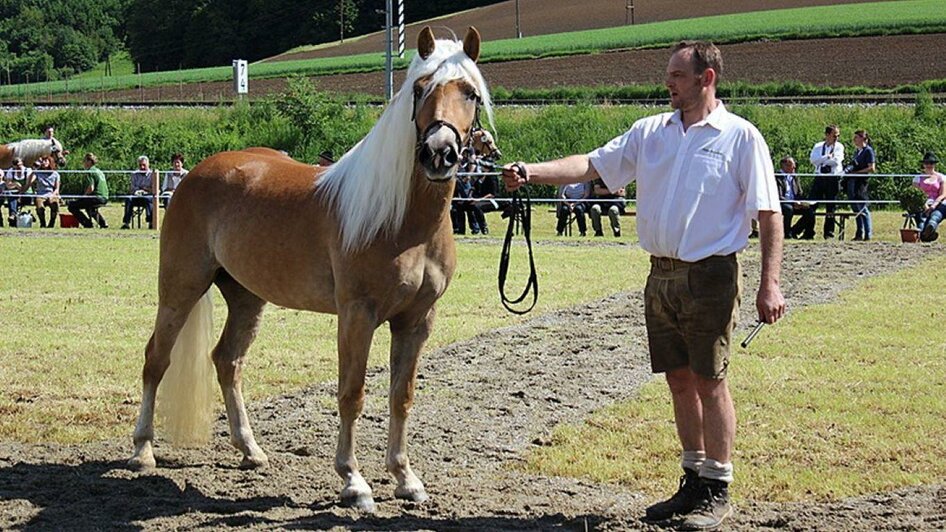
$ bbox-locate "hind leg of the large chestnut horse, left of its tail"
[128,288,210,469]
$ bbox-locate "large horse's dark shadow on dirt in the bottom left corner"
[0,461,294,530]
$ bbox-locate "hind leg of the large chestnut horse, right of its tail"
[213,271,269,469]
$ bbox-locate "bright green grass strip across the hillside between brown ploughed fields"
[0,0,946,97]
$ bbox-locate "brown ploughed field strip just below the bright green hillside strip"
[68,33,946,103]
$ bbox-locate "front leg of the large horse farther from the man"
[335,302,378,511]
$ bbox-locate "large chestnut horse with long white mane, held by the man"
[129,28,492,509]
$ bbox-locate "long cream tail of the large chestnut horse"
[156,291,216,446]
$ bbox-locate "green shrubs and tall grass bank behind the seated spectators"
[0,85,946,200]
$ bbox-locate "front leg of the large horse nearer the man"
[386,308,434,502]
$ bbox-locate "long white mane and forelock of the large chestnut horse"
[318,40,495,252]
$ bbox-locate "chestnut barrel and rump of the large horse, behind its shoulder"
[161,148,337,310]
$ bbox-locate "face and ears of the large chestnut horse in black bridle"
[413,27,483,181]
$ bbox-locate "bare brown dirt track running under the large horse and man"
[0,242,946,530]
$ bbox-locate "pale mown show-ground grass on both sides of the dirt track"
[0,205,946,500]
